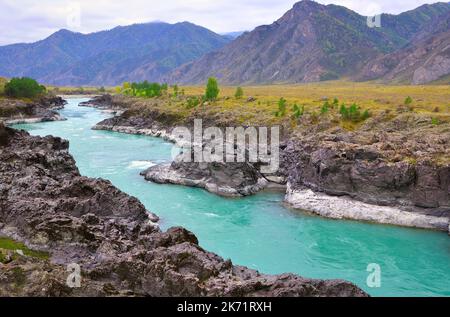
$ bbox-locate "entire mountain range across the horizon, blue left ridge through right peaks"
[0,0,450,85]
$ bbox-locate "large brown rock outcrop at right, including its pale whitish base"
[282,114,450,231]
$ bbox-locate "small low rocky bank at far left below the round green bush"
[0,96,66,125]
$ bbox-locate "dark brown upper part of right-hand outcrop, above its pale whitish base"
[282,114,450,212]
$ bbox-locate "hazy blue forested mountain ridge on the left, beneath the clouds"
[0,22,230,85]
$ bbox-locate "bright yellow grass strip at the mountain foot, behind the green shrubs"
[184,81,450,115]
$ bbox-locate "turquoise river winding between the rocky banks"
[15,99,450,296]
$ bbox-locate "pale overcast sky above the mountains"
[0,0,437,45]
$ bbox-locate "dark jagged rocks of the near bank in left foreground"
[0,126,366,296]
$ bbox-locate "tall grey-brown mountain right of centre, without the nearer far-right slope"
[164,0,450,84]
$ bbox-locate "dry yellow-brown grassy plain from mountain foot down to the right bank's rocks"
[121,81,450,130]
